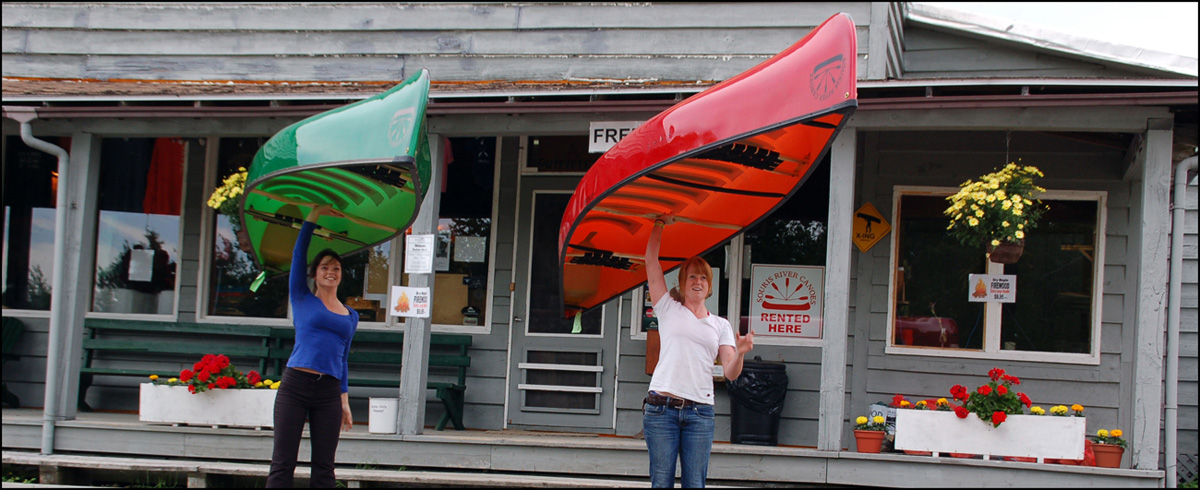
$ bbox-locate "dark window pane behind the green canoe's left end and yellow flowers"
[202,138,289,318]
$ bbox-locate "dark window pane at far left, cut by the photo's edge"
[4,136,64,310]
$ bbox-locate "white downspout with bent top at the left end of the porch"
[5,107,67,454]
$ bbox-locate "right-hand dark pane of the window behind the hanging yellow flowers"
[1000,199,1099,353]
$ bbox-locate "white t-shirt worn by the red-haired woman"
[650,294,737,405]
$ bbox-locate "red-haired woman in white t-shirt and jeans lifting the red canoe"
[642,214,754,488]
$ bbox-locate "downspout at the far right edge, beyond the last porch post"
[1164,156,1196,489]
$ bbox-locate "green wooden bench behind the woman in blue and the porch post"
[270,328,472,430]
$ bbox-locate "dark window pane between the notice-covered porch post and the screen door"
[402,138,496,325]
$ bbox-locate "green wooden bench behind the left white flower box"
[78,318,271,412]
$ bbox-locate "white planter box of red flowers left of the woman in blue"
[138,354,280,429]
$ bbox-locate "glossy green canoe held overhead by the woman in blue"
[241,70,430,275]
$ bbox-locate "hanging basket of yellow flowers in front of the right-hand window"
[943,163,1049,264]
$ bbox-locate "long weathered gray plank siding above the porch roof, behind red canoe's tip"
[2,2,887,82]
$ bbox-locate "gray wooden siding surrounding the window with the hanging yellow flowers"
[842,131,1139,441]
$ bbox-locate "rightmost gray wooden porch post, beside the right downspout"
[1118,119,1174,470]
